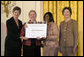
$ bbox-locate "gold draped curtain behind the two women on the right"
[43,1,83,56]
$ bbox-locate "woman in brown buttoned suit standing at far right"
[59,7,78,56]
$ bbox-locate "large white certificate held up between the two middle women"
[25,24,47,38]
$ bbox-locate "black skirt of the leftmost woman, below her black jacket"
[4,38,22,56]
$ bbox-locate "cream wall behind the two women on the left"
[1,1,43,56]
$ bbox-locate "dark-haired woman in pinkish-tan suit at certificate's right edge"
[43,12,59,56]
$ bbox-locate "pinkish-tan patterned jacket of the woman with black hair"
[44,22,59,47]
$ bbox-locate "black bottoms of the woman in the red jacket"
[23,45,41,56]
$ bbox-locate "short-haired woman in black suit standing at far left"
[5,6,22,56]
